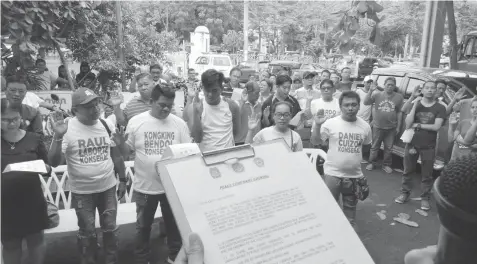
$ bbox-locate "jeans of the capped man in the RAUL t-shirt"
[71,186,118,264]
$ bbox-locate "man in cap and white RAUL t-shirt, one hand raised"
[48,88,127,264]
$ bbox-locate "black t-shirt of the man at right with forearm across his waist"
[411,102,446,148]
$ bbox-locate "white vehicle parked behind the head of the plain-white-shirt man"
[192,54,233,77]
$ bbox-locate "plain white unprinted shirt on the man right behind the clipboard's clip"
[199,100,234,151]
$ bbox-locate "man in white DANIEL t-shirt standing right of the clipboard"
[320,91,372,230]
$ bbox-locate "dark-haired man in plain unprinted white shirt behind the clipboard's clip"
[184,69,240,151]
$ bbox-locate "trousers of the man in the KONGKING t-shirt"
[133,191,182,264]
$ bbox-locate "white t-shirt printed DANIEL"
[320,116,372,178]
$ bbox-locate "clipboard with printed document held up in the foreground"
[157,140,374,264]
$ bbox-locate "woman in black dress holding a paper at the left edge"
[1,99,51,264]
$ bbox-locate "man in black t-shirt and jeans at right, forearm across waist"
[394,81,446,210]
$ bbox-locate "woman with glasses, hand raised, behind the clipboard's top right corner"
[245,101,303,152]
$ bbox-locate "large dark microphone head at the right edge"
[434,154,477,241]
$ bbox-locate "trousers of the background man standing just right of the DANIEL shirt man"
[369,127,396,167]
